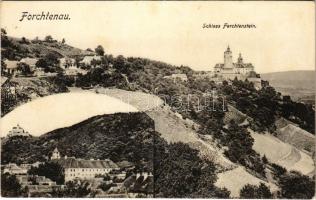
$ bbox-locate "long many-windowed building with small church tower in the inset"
[51,148,119,182]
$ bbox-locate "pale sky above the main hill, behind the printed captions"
[1,1,315,73]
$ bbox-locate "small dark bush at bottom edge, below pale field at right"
[240,183,272,199]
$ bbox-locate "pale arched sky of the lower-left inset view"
[0,91,138,137]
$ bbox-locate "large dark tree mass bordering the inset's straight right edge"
[154,137,229,198]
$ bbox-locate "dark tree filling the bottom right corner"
[279,171,315,199]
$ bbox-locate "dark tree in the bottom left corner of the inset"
[1,173,22,197]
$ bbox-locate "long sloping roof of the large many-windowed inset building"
[56,157,119,169]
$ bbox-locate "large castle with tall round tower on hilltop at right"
[214,46,259,80]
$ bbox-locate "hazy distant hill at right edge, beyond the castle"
[261,70,315,100]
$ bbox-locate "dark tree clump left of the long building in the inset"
[28,162,65,184]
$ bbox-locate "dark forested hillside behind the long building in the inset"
[1,113,155,167]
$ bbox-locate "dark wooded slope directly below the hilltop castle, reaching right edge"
[221,79,315,134]
